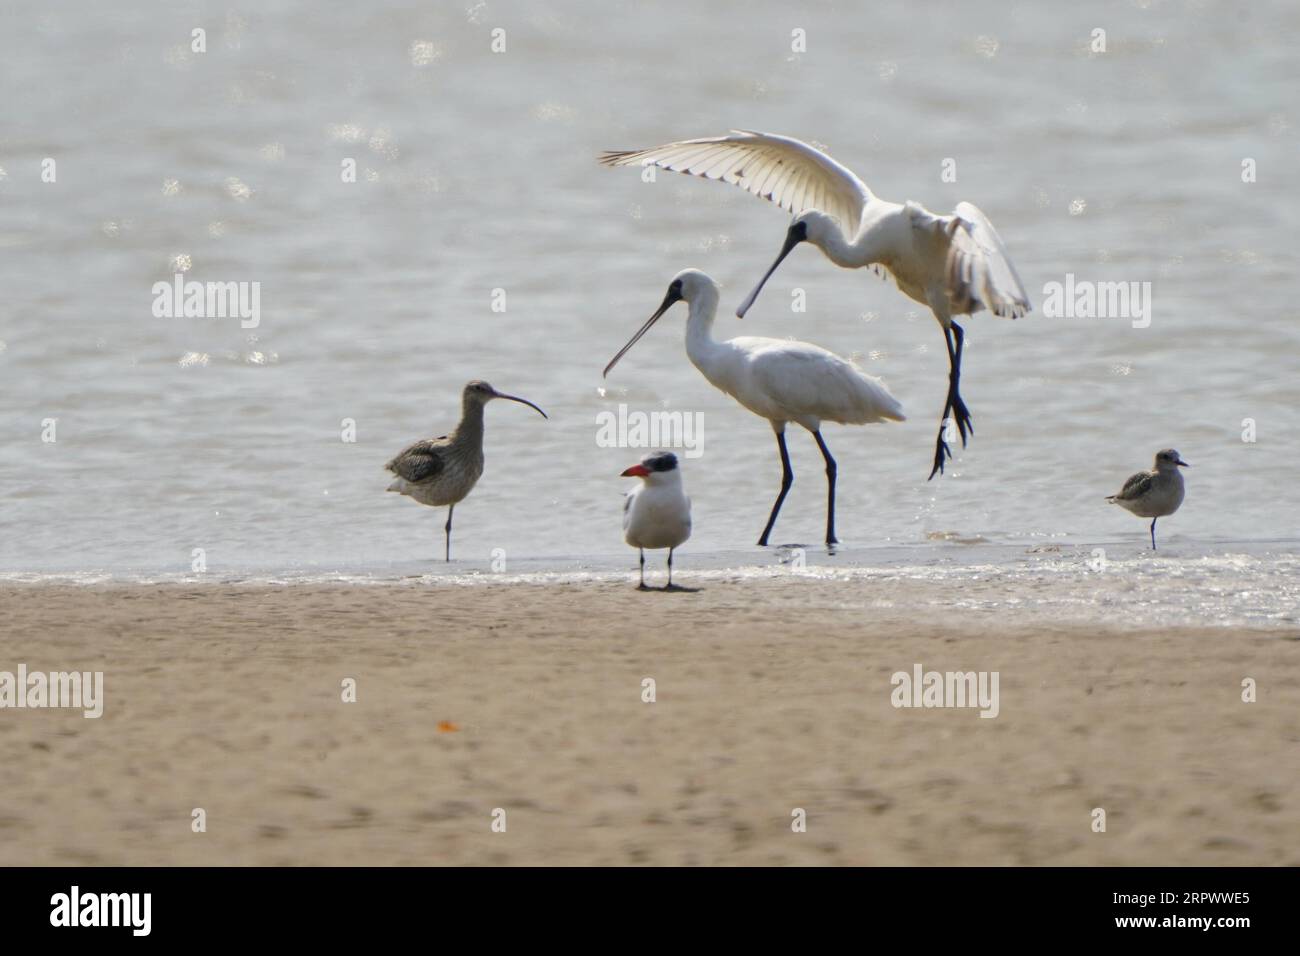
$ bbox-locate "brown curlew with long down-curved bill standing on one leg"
[384,380,547,561]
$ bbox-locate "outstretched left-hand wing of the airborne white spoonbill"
[601,130,872,239]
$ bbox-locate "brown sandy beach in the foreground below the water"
[0,576,1300,865]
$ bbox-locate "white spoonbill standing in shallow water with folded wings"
[605,269,904,545]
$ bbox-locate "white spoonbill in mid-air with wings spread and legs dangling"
[601,130,1032,477]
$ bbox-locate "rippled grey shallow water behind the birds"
[0,0,1300,574]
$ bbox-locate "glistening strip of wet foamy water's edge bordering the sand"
[0,542,1300,627]
